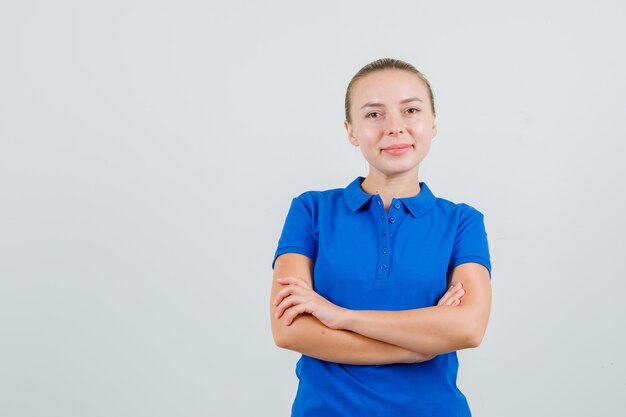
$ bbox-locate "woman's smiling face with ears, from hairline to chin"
[345,70,437,178]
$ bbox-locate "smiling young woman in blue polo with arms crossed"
[270,59,491,417]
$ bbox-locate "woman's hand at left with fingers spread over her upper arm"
[274,277,348,329]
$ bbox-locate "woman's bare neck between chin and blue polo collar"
[361,169,421,208]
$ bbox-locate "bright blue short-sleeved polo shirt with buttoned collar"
[274,177,491,417]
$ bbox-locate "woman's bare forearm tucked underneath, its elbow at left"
[272,315,430,365]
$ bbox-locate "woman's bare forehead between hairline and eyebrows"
[352,70,430,105]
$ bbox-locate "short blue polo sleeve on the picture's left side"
[272,194,318,268]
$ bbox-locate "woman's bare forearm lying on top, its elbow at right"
[344,306,486,355]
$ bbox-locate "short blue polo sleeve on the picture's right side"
[448,205,491,277]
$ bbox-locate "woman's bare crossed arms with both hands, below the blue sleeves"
[270,253,491,365]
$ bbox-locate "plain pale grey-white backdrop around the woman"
[0,0,626,417]
